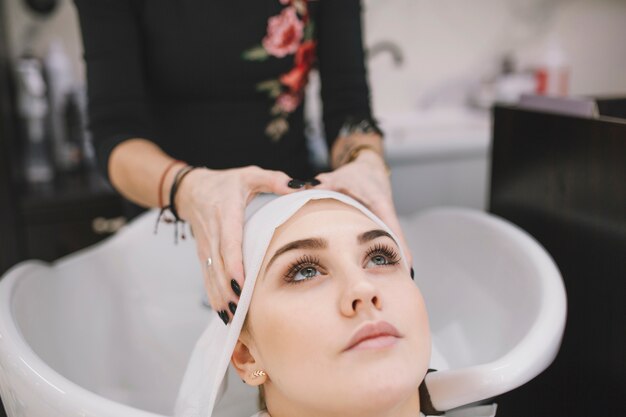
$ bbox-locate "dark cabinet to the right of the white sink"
[490,99,626,417]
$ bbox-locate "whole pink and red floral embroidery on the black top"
[242,0,317,141]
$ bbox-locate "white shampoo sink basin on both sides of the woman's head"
[0,209,566,417]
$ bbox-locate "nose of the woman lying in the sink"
[340,271,382,317]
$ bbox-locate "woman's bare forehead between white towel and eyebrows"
[272,198,377,245]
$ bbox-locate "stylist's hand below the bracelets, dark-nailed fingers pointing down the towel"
[176,166,295,324]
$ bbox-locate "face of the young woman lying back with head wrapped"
[242,199,430,416]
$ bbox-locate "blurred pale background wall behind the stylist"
[6,0,626,114]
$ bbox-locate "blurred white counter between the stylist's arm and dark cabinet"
[379,109,491,215]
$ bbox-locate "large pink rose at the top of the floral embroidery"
[263,7,304,58]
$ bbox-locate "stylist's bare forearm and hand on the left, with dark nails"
[109,139,295,323]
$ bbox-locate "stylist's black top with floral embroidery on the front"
[75,0,371,182]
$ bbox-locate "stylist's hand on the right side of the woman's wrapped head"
[315,149,413,265]
